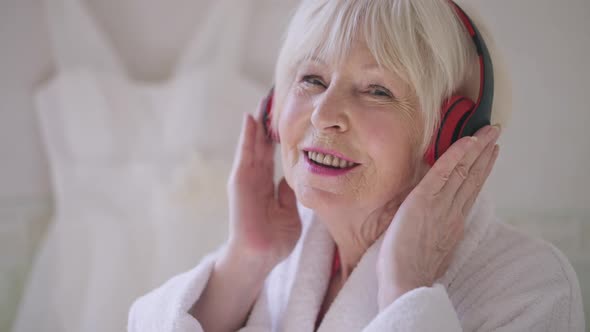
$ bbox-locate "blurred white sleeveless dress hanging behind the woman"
[13,0,265,332]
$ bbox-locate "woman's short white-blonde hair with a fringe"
[273,0,477,154]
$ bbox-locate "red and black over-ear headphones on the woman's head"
[263,1,494,166]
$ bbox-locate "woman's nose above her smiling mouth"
[311,90,350,132]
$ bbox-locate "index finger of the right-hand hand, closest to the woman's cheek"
[424,136,478,196]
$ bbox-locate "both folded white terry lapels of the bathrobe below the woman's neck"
[279,213,382,332]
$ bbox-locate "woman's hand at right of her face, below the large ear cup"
[377,126,500,309]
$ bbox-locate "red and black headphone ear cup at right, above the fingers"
[424,95,475,166]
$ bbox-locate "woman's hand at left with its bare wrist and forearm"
[189,104,301,331]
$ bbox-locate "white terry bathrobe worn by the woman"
[128,193,585,332]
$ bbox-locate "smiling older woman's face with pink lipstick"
[278,43,421,212]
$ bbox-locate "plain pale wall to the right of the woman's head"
[478,0,590,213]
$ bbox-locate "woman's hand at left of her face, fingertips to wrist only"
[228,102,301,270]
